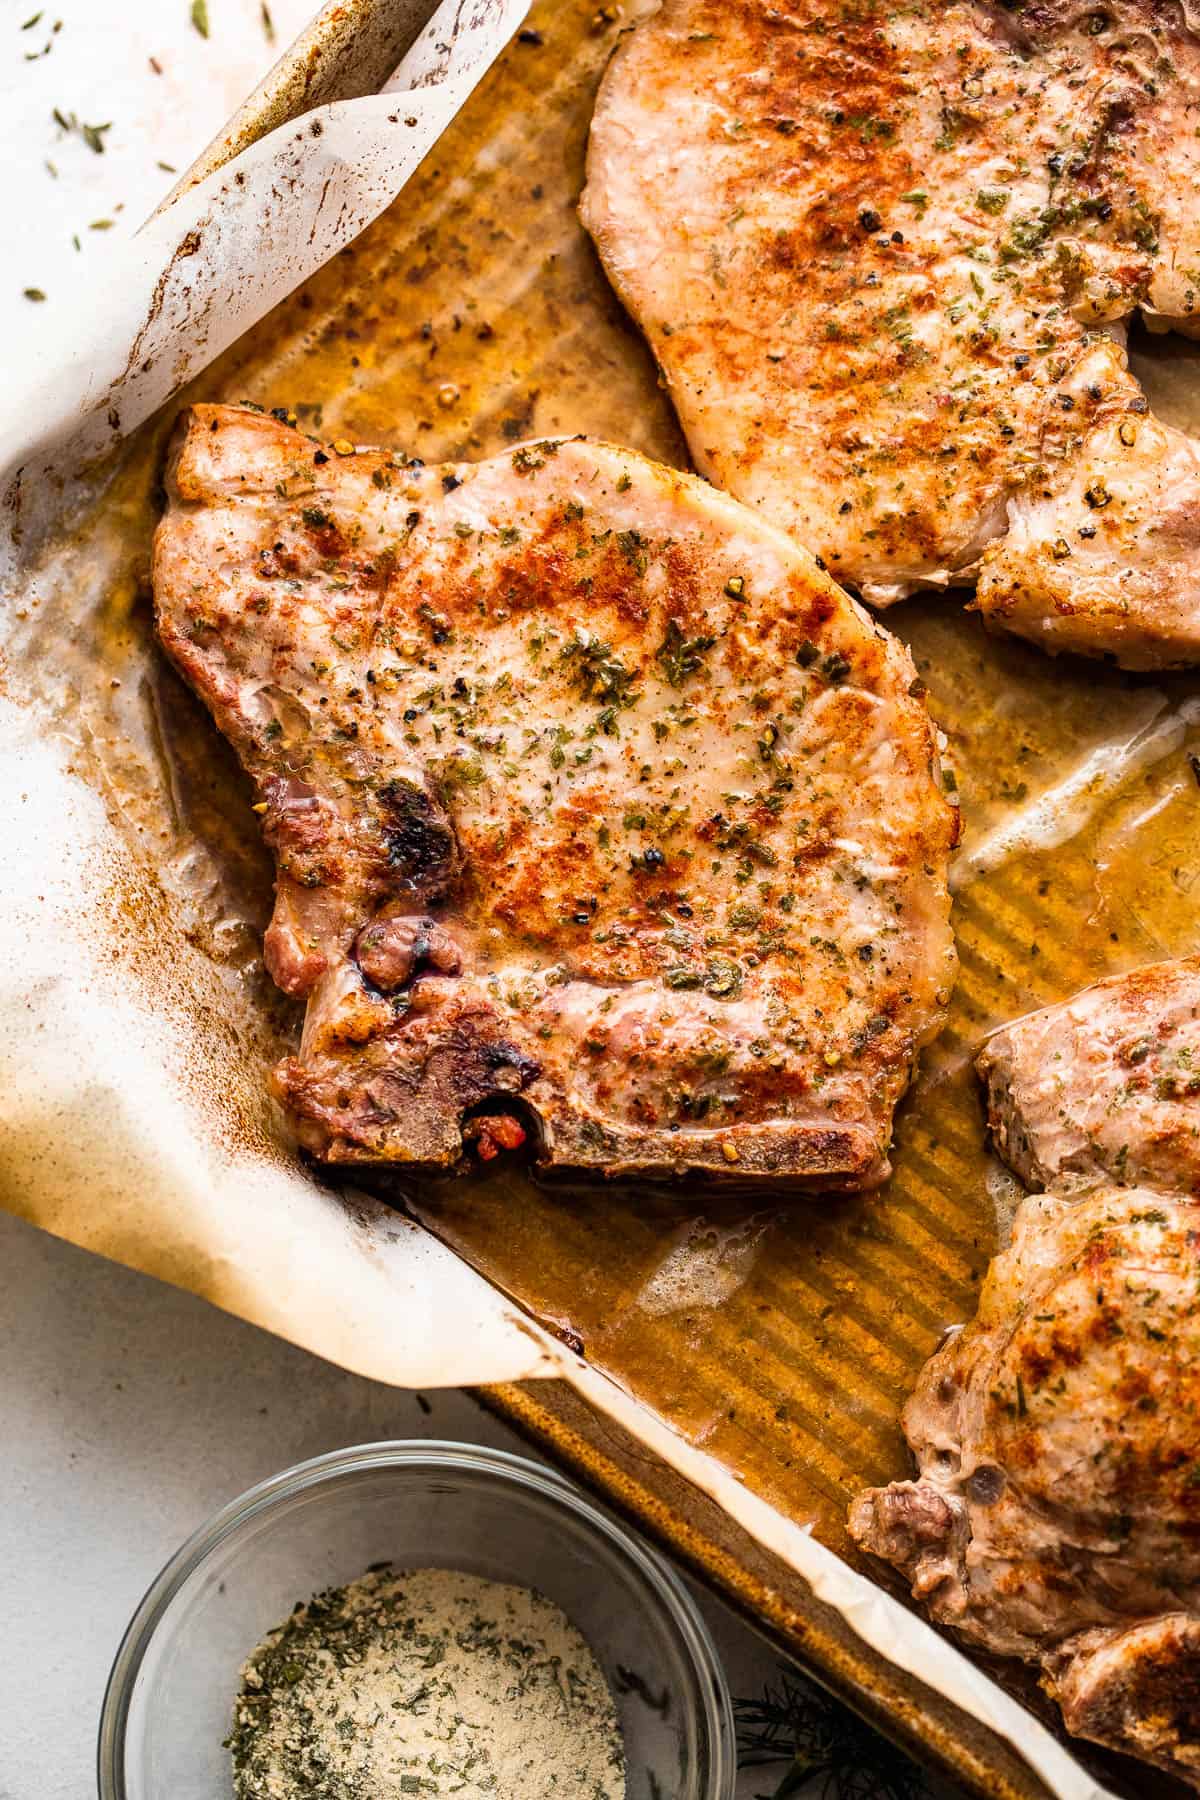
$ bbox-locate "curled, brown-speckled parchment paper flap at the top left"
[0,0,529,574]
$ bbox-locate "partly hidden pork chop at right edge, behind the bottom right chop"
[977,956,1200,1197]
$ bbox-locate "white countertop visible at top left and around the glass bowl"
[0,14,957,1800]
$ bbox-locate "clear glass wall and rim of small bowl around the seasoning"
[99,1440,736,1800]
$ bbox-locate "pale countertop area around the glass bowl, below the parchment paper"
[0,1213,791,1800]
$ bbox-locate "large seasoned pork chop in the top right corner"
[583,0,1200,668]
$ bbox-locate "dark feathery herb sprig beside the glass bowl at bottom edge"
[734,1672,930,1800]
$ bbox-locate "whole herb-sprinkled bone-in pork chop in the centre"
[155,407,955,1188]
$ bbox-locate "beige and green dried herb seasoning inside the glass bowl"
[228,1566,624,1800]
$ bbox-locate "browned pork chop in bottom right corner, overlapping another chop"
[849,1188,1200,1787]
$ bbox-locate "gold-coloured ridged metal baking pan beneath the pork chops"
[28,0,1200,1800]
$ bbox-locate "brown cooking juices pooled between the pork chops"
[14,0,1200,1552]
